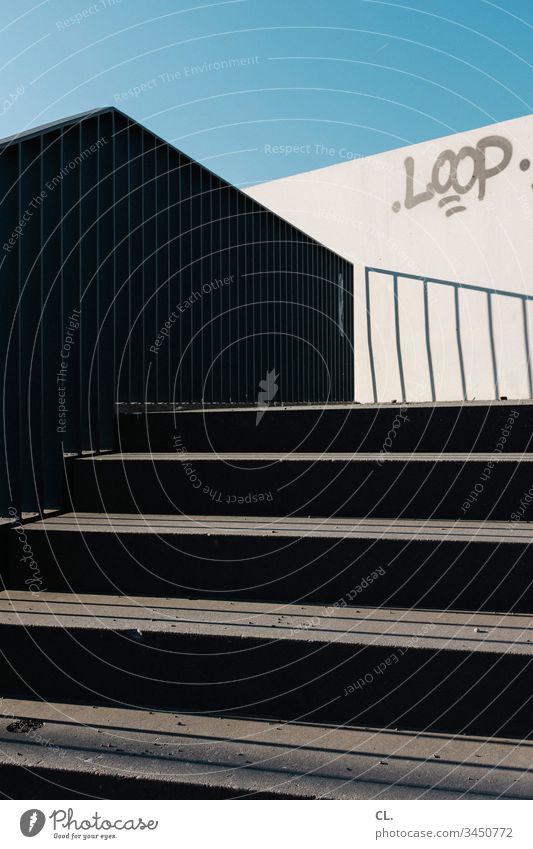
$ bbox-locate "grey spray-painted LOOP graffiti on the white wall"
[392,136,531,217]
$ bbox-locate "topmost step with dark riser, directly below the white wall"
[117,401,533,453]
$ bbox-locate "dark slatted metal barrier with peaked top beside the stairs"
[0,109,353,515]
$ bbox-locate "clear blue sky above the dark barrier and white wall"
[0,0,533,186]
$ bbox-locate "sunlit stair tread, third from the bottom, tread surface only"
[25,512,533,544]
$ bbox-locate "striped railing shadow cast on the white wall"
[365,267,533,403]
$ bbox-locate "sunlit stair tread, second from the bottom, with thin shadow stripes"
[0,590,533,656]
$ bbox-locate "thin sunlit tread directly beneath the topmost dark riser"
[76,450,533,463]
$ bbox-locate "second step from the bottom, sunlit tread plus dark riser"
[0,592,533,738]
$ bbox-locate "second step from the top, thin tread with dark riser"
[70,452,533,521]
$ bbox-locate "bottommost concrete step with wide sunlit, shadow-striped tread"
[0,699,533,800]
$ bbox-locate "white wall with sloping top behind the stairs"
[248,116,533,402]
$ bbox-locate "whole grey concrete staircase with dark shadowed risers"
[0,402,533,799]
